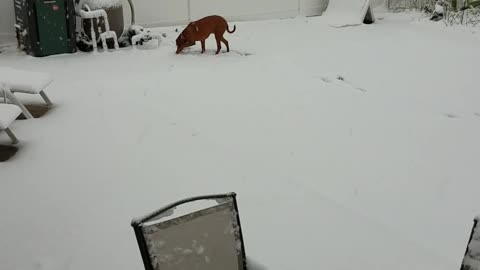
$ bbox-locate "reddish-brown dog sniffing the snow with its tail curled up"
[177,15,237,54]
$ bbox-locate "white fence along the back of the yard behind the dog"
[0,0,328,44]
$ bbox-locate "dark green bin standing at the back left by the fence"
[14,0,77,57]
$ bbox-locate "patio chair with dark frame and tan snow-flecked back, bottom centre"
[131,193,248,270]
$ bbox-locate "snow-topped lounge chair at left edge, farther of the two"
[0,67,53,118]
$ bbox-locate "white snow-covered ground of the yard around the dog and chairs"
[0,11,480,270]
